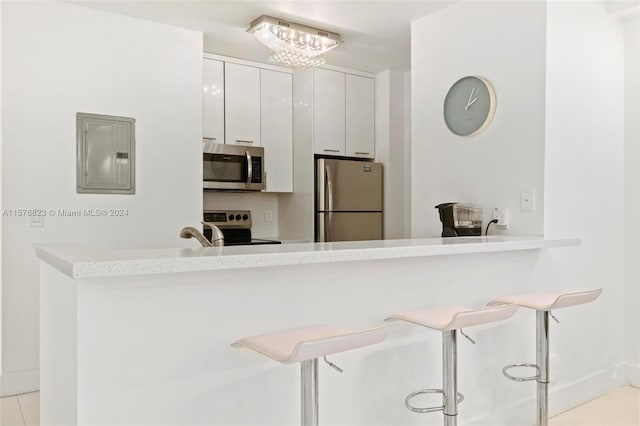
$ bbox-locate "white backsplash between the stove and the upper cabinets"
[202,192,278,238]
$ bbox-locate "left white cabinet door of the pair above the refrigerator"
[313,68,345,155]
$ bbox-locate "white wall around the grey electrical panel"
[2,2,202,394]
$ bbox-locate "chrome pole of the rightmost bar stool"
[536,311,549,426]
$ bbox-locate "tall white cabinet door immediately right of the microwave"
[260,69,293,192]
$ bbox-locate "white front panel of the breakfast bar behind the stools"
[41,249,615,425]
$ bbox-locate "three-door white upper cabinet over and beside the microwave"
[203,53,293,192]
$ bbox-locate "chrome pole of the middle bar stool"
[442,330,458,426]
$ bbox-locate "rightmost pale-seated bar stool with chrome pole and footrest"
[489,288,602,426]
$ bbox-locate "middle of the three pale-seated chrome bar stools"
[385,305,517,426]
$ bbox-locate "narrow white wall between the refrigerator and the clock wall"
[375,70,411,239]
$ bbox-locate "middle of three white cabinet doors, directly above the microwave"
[224,62,260,146]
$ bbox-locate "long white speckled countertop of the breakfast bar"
[35,236,581,279]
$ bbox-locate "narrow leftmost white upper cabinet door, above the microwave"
[202,59,224,143]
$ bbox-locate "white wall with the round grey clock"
[411,1,546,237]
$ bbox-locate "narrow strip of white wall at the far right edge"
[624,16,640,386]
